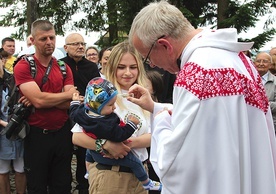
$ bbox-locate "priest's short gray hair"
[129,0,194,47]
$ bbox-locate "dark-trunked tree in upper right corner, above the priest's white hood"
[217,0,276,51]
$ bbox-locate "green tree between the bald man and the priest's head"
[74,0,150,46]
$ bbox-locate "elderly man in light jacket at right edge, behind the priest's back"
[254,52,276,132]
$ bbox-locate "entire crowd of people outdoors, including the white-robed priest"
[0,0,276,194]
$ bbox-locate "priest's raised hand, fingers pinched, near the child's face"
[127,84,154,113]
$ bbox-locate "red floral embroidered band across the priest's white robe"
[175,63,268,113]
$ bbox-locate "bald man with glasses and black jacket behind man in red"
[61,33,100,194]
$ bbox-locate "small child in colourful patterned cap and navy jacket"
[70,77,162,190]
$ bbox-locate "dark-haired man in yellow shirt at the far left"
[2,37,16,73]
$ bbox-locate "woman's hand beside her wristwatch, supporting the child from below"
[103,141,130,159]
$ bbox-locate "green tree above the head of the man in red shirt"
[0,0,81,40]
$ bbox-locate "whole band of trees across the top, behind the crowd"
[0,0,276,49]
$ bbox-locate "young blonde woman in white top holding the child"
[72,41,151,194]
